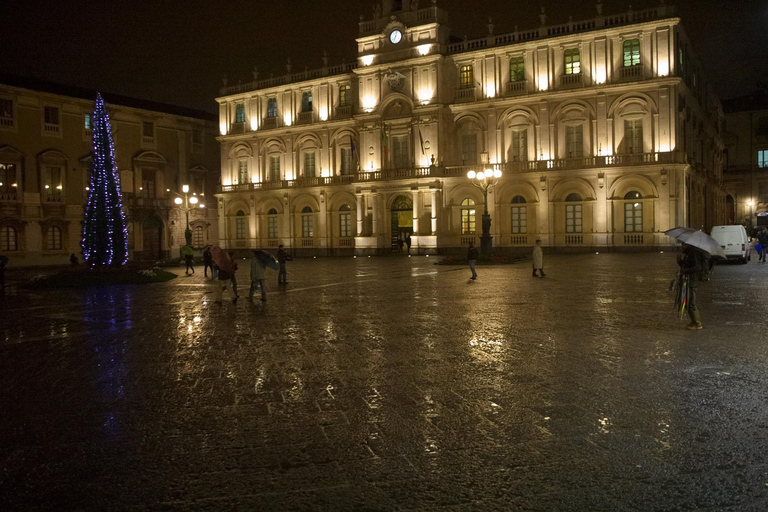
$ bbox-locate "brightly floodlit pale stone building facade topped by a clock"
[217,3,725,254]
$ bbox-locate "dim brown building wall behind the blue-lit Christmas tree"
[0,85,220,266]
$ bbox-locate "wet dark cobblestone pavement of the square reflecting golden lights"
[0,254,768,511]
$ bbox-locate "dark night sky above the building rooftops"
[0,0,768,112]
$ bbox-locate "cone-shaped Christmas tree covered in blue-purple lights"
[81,94,128,267]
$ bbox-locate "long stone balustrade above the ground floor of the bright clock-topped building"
[222,151,686,192]
